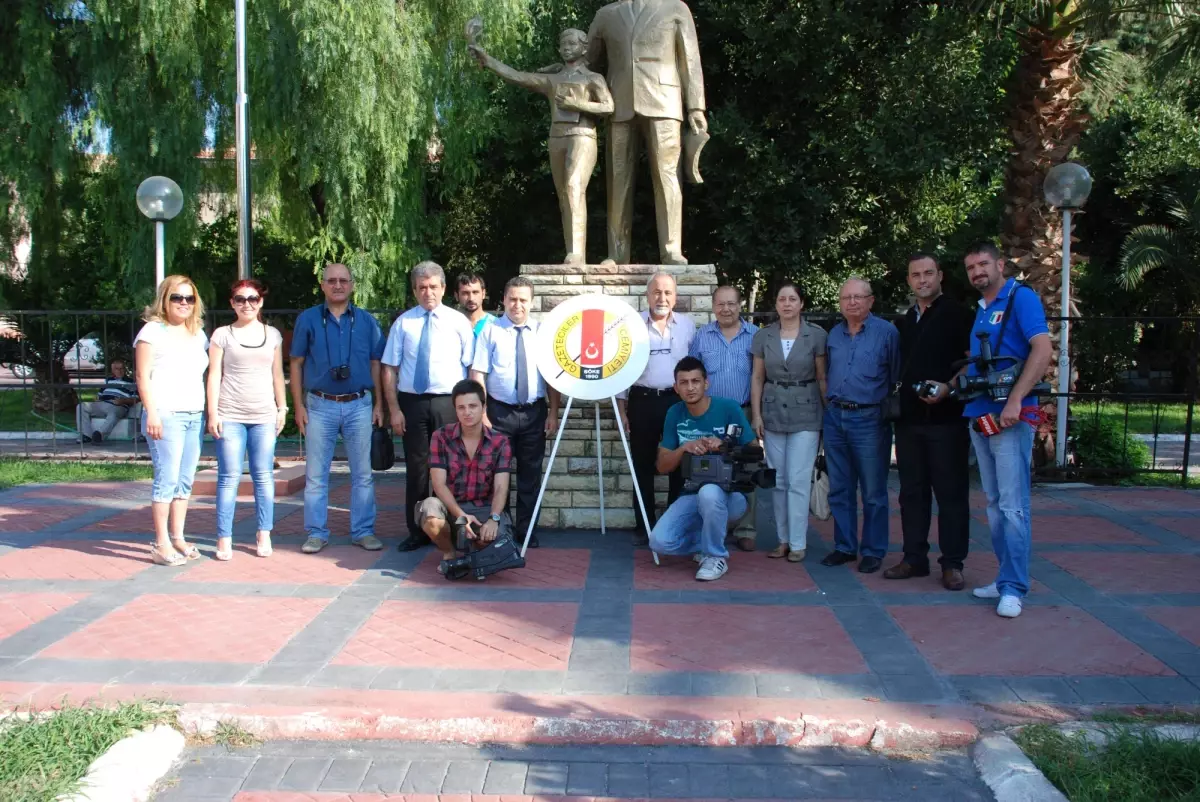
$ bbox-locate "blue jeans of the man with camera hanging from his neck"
[304,393,376,541]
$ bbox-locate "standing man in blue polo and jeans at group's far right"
[955,243,1051,618]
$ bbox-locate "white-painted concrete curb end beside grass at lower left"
[59,724,184,802]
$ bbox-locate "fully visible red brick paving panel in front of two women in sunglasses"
[41,594,329,663]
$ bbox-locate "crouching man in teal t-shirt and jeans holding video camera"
[650,357,754,581]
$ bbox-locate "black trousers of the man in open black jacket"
[895,419,971,570]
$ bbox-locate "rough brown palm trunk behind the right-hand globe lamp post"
[1001,28,1090,465]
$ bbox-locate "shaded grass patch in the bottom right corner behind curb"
[1016,724,1200,802]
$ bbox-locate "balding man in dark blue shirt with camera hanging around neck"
[290,264,384,555]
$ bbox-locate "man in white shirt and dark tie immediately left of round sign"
[470,276,558,549]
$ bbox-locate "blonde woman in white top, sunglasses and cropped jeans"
[133,276,209,565]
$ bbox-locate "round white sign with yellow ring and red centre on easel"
[538,295,650,401]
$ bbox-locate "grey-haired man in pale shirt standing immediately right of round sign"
[617,273,696,545]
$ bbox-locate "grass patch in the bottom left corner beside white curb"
[0,702,174,802]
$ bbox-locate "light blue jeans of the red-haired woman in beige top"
[217,421,275,538]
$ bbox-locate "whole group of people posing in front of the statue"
[136,243,1050,617]
